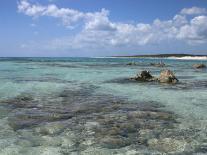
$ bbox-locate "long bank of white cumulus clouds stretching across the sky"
[18,0,207,50]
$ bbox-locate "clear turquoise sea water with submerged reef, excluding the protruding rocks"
[0,58,207,155]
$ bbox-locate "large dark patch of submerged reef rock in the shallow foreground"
[1,85,206,154]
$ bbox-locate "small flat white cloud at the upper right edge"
[180,7,207,15]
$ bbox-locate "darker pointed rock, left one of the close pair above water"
[131,70,157,82]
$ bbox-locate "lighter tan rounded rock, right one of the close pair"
[158,70,178,83]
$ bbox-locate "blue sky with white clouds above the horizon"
[0,0,207,57]
